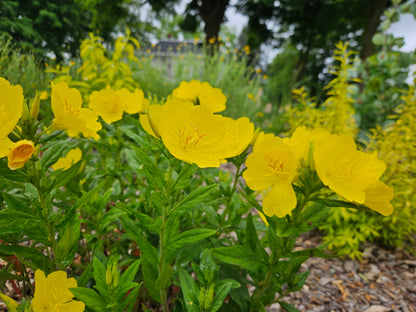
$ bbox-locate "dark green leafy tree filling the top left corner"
[0,0,88,61]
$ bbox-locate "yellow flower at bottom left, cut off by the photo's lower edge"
[32,270,85,312]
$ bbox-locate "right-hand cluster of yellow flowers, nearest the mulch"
[243,127,393,217]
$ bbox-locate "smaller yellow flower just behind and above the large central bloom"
[172,80,227,113]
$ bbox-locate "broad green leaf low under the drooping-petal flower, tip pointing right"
[211,246,268,272]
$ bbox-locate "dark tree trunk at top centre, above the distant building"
[199,0,230,53]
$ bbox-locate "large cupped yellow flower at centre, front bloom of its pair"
[159,98,227,168]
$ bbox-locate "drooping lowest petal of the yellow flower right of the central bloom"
[263,182,297,218]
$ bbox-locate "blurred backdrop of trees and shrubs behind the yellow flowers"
[0,0,416,257]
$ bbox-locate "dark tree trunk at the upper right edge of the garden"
[360,0,389,60]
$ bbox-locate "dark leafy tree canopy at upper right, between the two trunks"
[237,0,388,94]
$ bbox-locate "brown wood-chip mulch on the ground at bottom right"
[269,232,416,312]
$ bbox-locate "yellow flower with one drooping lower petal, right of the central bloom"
[243,133,297,218]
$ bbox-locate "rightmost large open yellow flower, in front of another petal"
[313,135,386,204]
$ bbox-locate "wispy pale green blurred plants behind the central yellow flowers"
[133,41,263,118]
